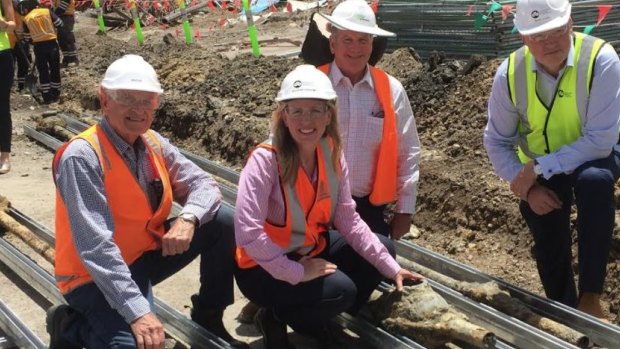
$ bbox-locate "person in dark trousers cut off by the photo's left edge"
[0,0,15,174]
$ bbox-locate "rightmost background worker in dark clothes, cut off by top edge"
[53,0,80,67]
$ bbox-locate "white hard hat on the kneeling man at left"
[101,55,164,93]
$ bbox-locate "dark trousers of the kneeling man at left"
[63,206,235,349]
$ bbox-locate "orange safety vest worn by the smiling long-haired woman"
[235,137,340,269]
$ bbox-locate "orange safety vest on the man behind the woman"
[317,64,398,206]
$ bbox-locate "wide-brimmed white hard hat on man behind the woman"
[321,0,396,36]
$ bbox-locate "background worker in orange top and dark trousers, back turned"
[17,0,62,103]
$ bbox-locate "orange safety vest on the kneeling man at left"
[53,125,172,294]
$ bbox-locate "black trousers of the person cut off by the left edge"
[0,50,15,153]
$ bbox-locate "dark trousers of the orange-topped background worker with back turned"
[34,40,60,101]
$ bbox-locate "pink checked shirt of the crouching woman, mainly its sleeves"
[235,148,400,285]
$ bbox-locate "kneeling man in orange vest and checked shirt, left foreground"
[47,55,249,349]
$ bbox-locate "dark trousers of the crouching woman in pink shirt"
[236,231,396,334]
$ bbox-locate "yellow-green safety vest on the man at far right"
[508,33,605,163]
